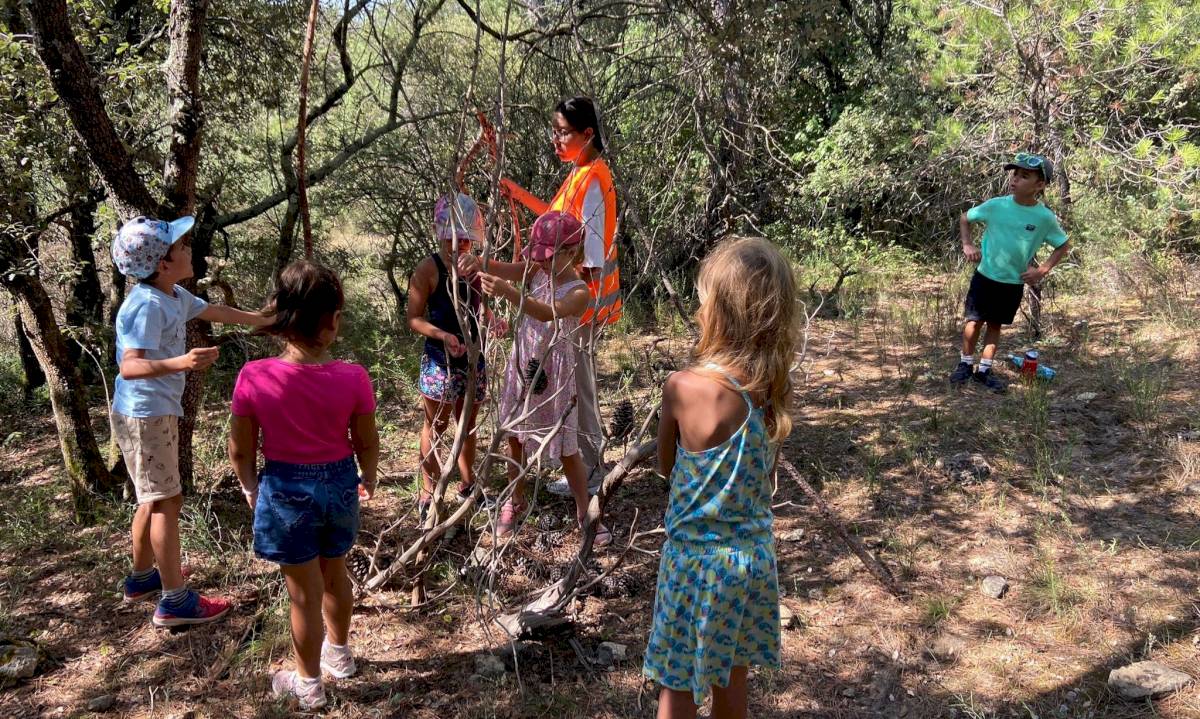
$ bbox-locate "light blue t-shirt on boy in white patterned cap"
[113,282,209,417]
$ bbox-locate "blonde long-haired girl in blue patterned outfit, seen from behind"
[643,238,798,719]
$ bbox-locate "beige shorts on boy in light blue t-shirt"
[113,412,184,504]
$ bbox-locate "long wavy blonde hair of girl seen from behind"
[694,238,799,442]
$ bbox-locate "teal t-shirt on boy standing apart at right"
[967,194,1067,284]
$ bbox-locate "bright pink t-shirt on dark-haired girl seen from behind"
[232,358,376,465]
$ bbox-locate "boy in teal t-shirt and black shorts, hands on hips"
[950,152,1070,393]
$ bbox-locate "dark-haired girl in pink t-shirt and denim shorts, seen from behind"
[229,262,379,709]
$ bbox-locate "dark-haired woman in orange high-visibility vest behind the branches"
[500,97,620,491]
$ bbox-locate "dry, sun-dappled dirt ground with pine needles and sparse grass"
[0,272,1200,719]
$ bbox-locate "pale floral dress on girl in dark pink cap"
[500,271,587,460]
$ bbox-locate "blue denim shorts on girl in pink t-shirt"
[254,455,359,564]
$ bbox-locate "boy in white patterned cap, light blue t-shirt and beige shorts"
[113,217,270,627]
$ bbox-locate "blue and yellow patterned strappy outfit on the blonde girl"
[642,365,780,705]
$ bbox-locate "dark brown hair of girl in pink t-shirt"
[263,259,346,344]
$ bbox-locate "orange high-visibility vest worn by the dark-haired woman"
[550,157,620,324]
